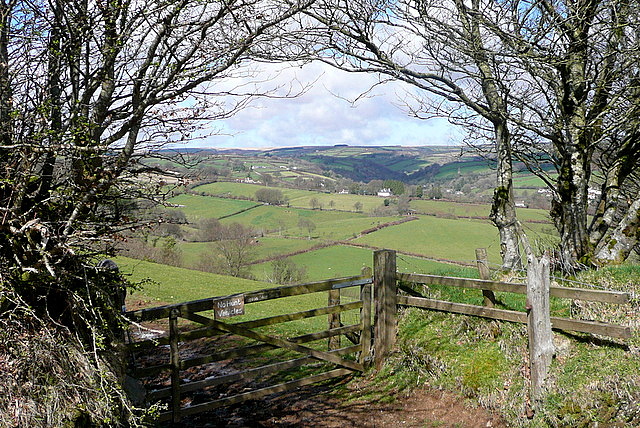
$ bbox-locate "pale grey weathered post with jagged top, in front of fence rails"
[526,254,554,408]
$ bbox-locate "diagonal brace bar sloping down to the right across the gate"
[183,314,364,371]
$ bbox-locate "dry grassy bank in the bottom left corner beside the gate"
[0,289,151,428]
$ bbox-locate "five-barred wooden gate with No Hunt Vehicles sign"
[126,271,372,422]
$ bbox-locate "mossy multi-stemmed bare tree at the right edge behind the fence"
[476,0,640,267]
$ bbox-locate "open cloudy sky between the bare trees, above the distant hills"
[195,63,461,149]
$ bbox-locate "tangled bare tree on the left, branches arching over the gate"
[0,0,311,324]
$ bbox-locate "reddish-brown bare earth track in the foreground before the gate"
[183,380,507,428]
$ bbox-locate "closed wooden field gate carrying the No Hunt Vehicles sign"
[126,271,372,422]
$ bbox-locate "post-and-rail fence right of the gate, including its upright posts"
[374,250,631,402]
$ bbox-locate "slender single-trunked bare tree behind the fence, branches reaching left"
[308,0,520,268]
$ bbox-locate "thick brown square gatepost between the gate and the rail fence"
[373,250,398,370]
